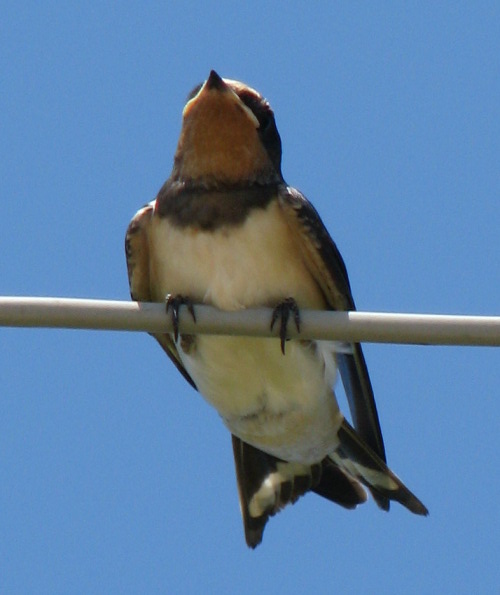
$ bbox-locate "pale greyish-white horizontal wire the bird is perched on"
[0,297,500,346]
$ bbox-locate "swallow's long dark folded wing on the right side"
[279,186,388,468]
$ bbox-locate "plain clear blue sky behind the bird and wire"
[0,1,500,594]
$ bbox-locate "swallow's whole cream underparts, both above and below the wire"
[151,203,342,462]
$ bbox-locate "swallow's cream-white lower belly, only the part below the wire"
[181,336,342,463]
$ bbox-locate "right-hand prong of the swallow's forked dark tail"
[329,420,429,515]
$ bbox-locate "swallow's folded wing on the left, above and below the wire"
[125,201,196,388]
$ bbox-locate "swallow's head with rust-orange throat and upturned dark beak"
[171,70,282,186]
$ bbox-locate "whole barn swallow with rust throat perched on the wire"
[126,71,428,547]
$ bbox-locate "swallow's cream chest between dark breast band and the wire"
[150,201,324,310]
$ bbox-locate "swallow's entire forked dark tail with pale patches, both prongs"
[233,420,428,548]
